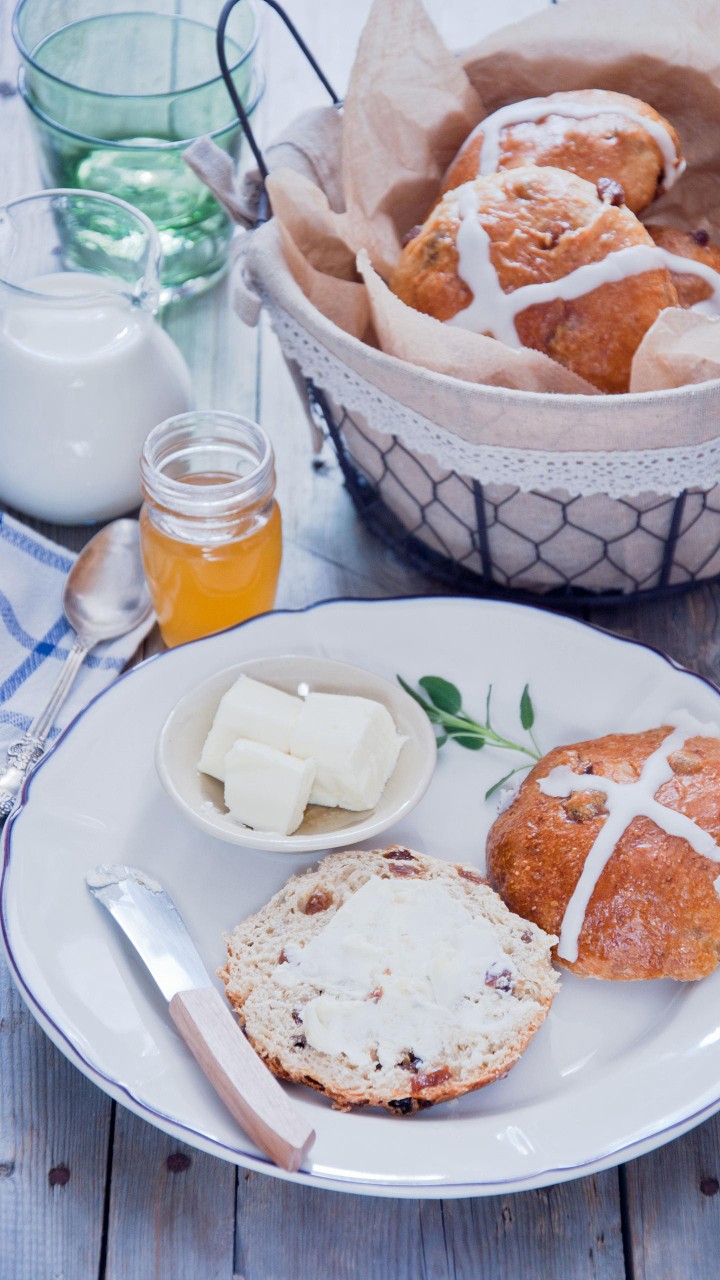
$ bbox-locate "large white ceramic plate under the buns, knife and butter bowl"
[1,598,720,1197]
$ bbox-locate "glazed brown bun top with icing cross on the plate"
[487,727,720,980]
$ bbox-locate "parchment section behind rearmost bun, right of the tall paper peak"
[462,0,720,233]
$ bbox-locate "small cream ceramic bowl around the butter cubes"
[155,654,437,854]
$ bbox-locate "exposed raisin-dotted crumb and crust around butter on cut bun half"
[219,846,557,1115]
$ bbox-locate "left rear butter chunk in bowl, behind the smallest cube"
[197,676,302,782]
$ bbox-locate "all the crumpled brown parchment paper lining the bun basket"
[244,0,720,394]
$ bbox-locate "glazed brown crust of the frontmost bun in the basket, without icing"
[389,168,678,393]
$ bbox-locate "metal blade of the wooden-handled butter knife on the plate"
[85,864,213,1002]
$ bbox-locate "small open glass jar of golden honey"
[140,410,282,648]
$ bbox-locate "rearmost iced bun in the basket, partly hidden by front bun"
[442,88,684,214]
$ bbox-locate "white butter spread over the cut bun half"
[275,876,509,1069]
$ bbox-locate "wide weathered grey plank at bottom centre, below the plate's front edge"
[236,1171,625,1280]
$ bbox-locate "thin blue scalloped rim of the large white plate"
[0,594,720,1198]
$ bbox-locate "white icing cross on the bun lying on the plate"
[538,712,720,963]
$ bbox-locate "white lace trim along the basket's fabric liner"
[255,299,720,498]
